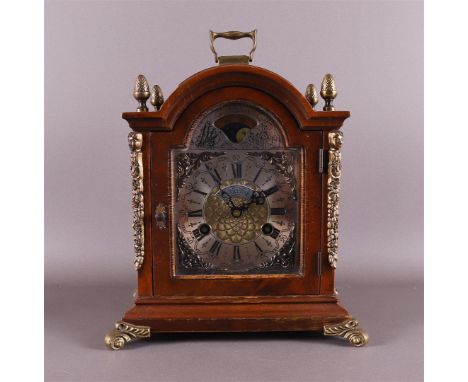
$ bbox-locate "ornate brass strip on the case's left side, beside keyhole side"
[128,131,145,270]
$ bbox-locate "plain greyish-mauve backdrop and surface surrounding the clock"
[45,1,423,381]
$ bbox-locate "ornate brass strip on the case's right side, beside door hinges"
[327,130,343,268]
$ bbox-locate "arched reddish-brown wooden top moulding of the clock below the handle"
[122,64,350,131]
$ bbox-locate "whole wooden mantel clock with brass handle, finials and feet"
[105,30,368,349]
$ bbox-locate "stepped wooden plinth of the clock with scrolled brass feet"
[106,296,368,349]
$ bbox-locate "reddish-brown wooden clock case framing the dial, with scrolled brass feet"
[106,64,367,349]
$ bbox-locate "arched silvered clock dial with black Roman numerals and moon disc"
[171,101,303,277]
